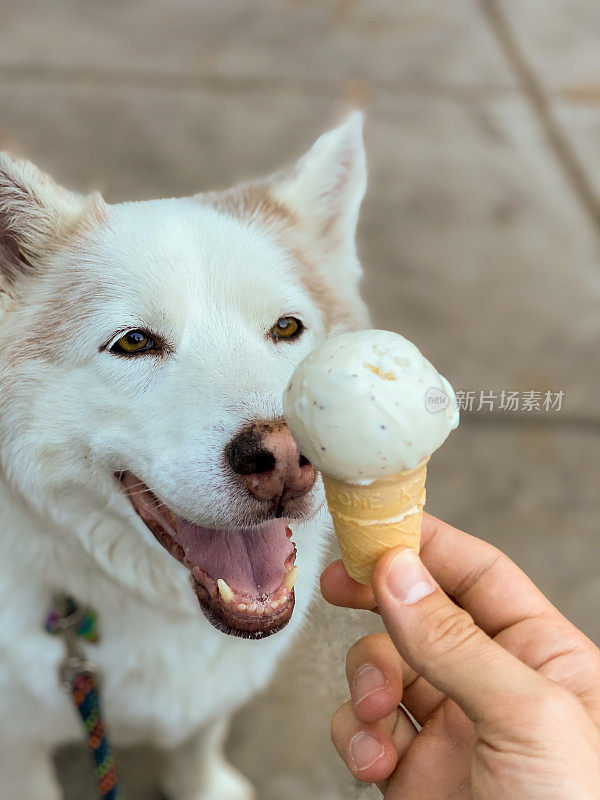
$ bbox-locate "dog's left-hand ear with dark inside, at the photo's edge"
[0,153,86,292]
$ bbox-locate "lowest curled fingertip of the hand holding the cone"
[331,701,416,783]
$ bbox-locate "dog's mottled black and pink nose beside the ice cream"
[225,420,317,501]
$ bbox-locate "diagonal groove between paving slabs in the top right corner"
[478,0,600,231]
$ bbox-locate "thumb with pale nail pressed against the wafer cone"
[373,549,545,727]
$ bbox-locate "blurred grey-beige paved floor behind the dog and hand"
[0,0,600,800]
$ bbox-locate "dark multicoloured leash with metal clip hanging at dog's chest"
[45,597,123,800]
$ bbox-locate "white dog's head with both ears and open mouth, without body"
[0,116,366,637]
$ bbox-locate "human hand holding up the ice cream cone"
[321,514,600,800]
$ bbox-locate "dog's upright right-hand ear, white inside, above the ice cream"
[271,111,367,247]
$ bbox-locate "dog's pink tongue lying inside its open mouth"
[176,519,294,597]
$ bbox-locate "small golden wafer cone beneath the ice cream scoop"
[323,461,427,585]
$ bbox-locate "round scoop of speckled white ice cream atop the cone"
[283,330,458,484]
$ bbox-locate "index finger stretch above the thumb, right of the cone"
[420,514,560,636]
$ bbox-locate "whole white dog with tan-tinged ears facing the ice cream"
[0,114,367,800]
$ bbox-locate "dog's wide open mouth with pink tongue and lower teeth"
[120,472,298,639]
